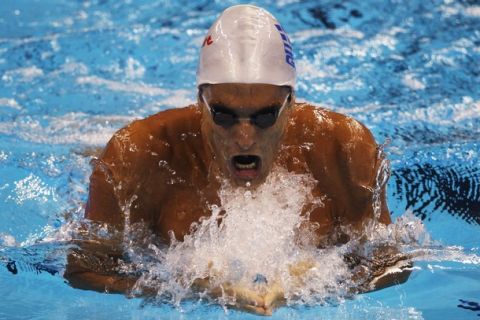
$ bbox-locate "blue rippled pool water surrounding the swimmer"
[0,0,480,319]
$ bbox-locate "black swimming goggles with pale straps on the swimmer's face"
[201,93,291,129]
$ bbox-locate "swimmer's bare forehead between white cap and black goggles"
[202,83,290,107]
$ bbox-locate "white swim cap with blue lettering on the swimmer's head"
[197,5,295,88]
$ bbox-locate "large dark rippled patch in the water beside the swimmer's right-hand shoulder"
[392,163,480,225]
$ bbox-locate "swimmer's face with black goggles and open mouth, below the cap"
[198,83,293,185]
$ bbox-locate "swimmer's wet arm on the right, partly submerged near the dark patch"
[320,119,412,292]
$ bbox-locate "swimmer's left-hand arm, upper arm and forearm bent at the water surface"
[64,126,173,295]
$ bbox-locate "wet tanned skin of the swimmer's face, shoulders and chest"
[65,84,408,316]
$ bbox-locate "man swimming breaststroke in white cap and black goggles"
[64,5,409,314]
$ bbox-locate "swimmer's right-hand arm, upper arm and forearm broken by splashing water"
[340,123,413,292]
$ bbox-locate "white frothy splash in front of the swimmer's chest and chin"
[133,168,349,303]
